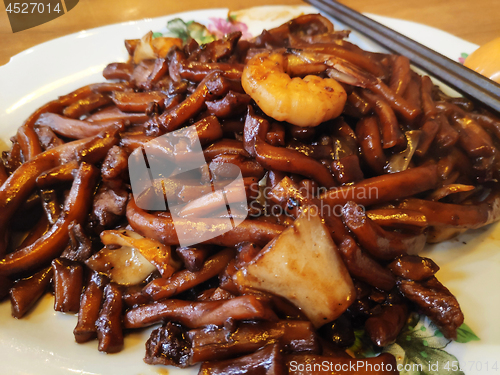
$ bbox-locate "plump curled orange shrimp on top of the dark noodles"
[241,52,347,127]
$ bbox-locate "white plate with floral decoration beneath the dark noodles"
[0,6,500,375]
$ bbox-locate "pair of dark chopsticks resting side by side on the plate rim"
[305,0,500,113]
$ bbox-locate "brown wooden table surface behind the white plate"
[0,0,500,65]
